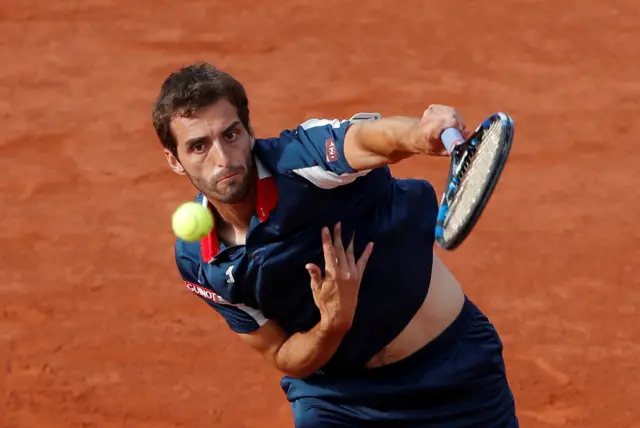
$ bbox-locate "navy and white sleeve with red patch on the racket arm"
[268,113,380,189]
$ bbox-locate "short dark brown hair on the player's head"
[153,62,251,157]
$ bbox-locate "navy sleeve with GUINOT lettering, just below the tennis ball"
[175,240,268,333]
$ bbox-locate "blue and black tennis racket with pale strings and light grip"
[435,113,514,251]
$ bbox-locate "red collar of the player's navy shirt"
[200,157,278,263]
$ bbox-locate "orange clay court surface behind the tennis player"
[0,0,640,428]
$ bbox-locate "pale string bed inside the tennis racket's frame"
[444,121,503,238]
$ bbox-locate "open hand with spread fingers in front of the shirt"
[305,223,373,334]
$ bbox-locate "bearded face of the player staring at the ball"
[165,98,254,204]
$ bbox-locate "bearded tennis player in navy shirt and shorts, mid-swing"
[153,63,518,428]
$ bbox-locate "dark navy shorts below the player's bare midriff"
[281,298,519,428]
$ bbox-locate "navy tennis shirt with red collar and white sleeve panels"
[175,113,438,371]
